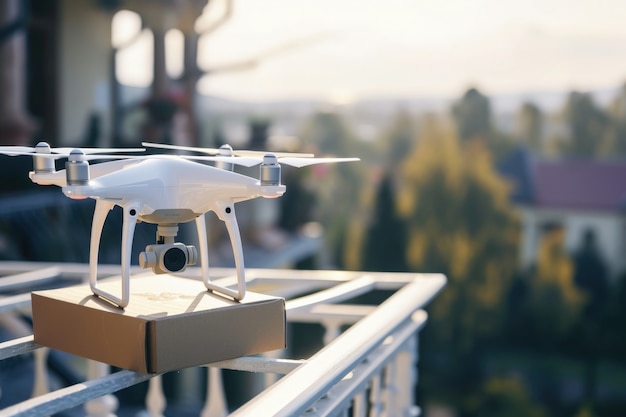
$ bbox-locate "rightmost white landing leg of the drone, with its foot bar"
[203,201,246,300]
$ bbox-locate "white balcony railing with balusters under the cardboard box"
[0,262,445,417]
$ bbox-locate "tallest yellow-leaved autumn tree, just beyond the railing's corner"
[400,116,519,409]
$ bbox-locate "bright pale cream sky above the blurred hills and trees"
[114,0,626,103]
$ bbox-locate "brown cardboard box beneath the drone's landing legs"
[32,275,286,373]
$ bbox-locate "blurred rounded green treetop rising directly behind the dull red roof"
[563,91,608,156]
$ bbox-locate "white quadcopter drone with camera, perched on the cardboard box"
[0,142,359,308]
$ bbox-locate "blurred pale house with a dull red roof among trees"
[498,149,626,277]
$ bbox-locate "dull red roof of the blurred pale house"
[534,160,626,210]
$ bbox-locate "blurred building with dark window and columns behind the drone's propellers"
[0,0,221,150]
